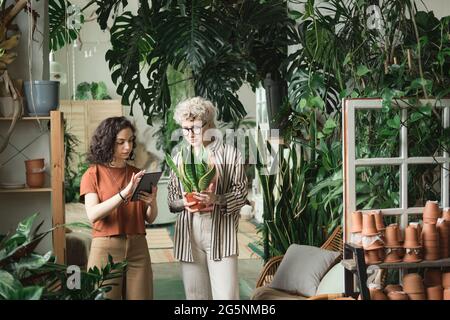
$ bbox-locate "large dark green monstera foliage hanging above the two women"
[91,0,294,124]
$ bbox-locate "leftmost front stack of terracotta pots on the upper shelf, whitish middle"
[361,211,384,265]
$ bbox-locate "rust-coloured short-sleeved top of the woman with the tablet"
[80,164,146,237]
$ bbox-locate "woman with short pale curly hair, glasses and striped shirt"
[168,97,247,300]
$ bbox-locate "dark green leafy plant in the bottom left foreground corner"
[0,214,126,300]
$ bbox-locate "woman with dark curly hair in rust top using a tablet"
[80,117,158,300]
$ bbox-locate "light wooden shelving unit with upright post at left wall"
[0,111,66,264]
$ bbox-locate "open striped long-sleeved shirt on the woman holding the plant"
[168,140,247,262]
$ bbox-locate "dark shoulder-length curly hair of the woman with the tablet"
[87,117,136,164]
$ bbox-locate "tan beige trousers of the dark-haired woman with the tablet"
[88,235,153,300]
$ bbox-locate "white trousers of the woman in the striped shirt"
[181,213,239,300]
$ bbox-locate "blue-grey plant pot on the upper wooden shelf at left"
[24,80,59,116]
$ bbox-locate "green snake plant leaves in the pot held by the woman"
[165,147,216,193]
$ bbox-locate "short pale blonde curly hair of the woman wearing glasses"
[174,97,216,127]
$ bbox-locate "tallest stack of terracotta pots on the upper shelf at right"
[422,201,442,260]
